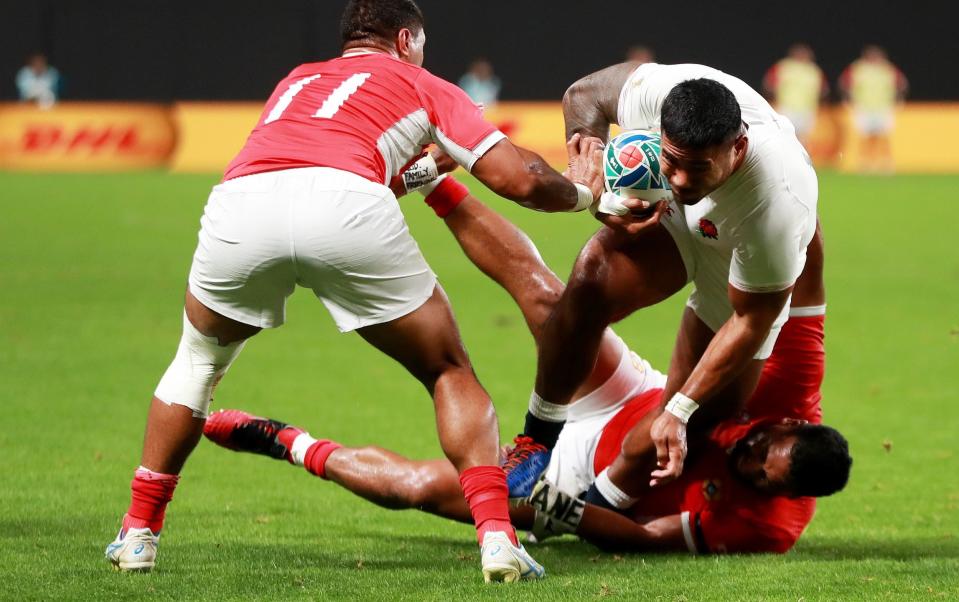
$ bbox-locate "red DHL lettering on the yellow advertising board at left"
[20,123,146,154]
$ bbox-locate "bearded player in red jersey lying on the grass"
[204,180,851,552]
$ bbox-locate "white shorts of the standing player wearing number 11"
[190,167,436,332]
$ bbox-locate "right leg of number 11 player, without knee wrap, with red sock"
[357,285,543,581]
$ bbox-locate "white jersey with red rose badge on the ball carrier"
[618,63,818,330]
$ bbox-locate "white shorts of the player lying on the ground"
[545,340,666,495]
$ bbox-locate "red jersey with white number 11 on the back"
[223,52,504,184]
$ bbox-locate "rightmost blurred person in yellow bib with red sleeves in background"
[839,45,909,172]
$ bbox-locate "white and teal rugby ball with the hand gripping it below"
[598,130,673,215]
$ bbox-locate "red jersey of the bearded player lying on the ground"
[593,316,825,553]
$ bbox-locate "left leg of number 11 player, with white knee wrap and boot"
[106,291,260,571]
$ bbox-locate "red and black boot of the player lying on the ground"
[203,410,303,462]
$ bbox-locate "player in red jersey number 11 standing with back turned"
[106,0,602,581]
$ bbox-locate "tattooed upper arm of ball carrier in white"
[563,62,640,142]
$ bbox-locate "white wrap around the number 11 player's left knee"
[154,312,246,418]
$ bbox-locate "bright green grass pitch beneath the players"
[0,173,959,600]
